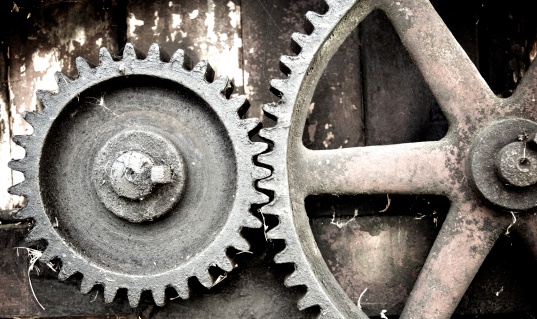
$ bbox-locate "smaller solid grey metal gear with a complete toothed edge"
[10,44,270,307]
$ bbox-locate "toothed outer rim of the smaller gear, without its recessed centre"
[9,44,270,307]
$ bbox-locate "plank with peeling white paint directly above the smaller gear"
[127,0,243,93]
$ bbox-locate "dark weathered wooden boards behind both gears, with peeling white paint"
[0,0,537,318]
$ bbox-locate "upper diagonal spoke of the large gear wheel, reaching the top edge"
[381,0,497,122]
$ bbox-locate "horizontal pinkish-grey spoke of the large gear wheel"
[290,142,451,195]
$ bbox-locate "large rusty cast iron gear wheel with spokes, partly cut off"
[255,0,537,318]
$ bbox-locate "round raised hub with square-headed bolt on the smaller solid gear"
[93,130,186,223]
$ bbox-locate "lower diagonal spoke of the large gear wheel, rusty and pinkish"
[401,203,510,319]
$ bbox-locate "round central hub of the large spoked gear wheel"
[469,119,537,211]
